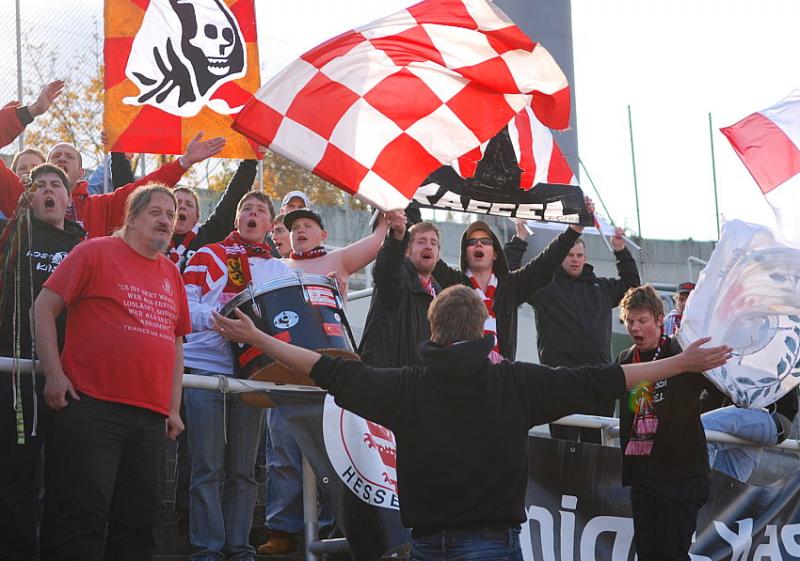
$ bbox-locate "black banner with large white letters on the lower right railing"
[522,437,800,561]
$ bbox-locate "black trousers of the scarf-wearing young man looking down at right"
[631,475,711,561]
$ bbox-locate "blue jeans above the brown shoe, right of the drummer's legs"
[264,406,335,536]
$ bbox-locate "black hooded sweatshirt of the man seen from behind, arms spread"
[311,336,625,532]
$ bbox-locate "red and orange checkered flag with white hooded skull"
[104,0,260,158]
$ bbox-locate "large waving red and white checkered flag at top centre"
[233,0,570,210]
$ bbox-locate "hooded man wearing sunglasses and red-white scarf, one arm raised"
[433,197,594,363]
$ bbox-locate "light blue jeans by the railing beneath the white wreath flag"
[700,405,778,483]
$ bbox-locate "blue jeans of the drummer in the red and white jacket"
[184,372,264,561]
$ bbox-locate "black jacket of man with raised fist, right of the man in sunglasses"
[530,248,640,366]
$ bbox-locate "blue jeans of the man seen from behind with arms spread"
[409,528,522,561]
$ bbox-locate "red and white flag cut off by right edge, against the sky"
[720,90,800,245]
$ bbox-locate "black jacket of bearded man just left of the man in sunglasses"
[358,232,442,367]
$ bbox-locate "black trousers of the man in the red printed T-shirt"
[55,395,165,561]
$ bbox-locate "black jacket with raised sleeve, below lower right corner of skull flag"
[172,160,258,271]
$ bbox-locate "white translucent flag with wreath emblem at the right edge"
[678,220,800,408]
